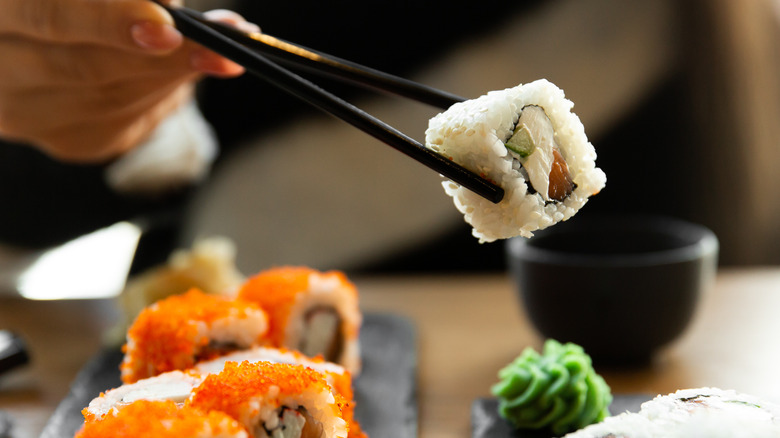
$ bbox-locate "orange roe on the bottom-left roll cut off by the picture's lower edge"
[75,400,247,438]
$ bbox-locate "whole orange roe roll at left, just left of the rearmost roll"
[120,289,268,383]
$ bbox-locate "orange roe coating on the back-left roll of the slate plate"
[121,289,264,383]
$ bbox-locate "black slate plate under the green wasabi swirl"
[471,394,652,438]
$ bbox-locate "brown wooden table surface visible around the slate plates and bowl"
[0,268,780,438]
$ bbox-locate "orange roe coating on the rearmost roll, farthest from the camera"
[238,266,357,347]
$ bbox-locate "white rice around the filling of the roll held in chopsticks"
[425,79,606,242]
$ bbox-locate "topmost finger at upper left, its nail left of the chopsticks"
[0,0,183,53]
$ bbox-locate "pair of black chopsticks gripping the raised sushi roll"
[157,5,504,203]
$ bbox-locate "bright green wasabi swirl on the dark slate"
[491,339,612,436]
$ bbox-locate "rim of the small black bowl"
[506,214,719,267]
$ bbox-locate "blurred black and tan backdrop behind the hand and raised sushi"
[0,0,780,274]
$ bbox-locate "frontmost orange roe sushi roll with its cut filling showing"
[188,361,348,438]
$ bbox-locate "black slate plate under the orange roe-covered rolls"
[41,314,417,438]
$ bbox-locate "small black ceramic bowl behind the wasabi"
[507,216,718,365]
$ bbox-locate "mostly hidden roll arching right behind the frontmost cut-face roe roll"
[193,347,367,438]
